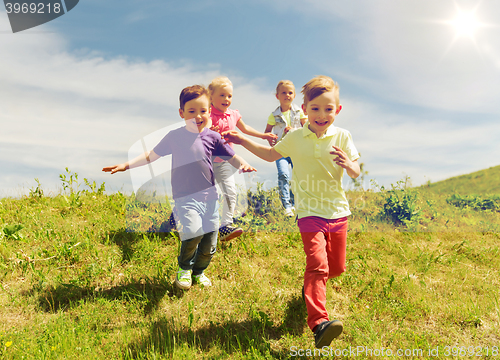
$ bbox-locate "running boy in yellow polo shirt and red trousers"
[223,76,360,348]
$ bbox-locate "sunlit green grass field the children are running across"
[0,168,500,359]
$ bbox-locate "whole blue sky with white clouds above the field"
[0,0,500,197]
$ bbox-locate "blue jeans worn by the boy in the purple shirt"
[175,197,219,275]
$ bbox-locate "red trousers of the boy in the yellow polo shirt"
[298,216,347,330]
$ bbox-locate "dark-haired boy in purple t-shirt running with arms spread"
[102,85,255,289]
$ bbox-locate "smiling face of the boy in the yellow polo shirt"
[302,91,342,138]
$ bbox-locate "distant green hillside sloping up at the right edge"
[422,165,500,195]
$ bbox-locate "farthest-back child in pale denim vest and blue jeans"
[264,80,307,216]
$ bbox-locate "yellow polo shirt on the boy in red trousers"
[274,121,359,219]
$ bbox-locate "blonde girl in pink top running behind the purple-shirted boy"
[208,76,276,241]
